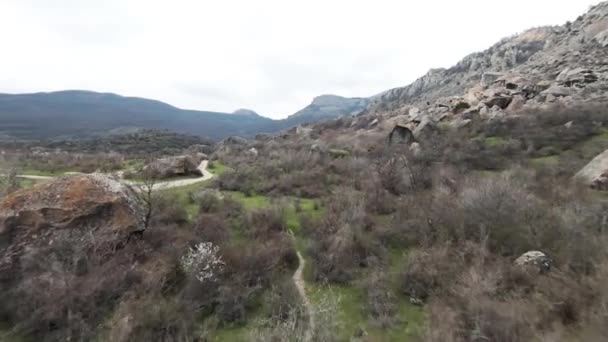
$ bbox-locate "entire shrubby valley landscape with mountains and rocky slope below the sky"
[0,2,608,342]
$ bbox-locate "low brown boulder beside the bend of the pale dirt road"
[144,153,205,178]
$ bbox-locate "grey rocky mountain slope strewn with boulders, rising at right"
[360,2,608,125]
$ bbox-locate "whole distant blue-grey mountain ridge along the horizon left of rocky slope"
[0,90,366,140]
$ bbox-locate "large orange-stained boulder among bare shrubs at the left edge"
[0,174,145,283]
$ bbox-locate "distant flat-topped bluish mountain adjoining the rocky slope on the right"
[287,95,369,125]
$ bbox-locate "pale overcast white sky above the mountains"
[0,0,600,118]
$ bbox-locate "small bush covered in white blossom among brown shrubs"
[181,242,224,283]
